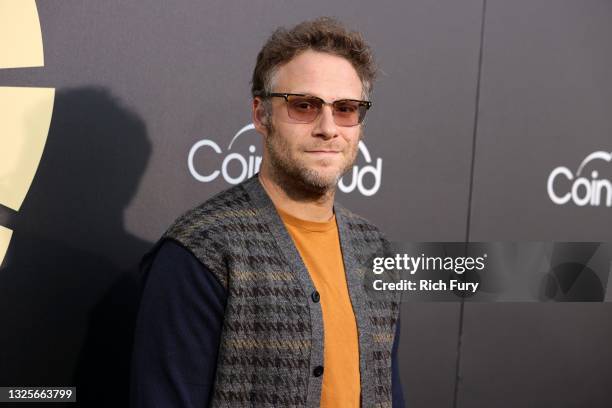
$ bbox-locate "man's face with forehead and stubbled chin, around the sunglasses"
[262,50,362,192]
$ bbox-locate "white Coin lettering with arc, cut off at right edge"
[546,151,612,207]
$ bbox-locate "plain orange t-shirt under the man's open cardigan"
[277,209,361,408]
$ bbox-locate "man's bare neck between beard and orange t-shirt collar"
[259,169,335,222]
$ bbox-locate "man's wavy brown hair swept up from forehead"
[251,17,376,98]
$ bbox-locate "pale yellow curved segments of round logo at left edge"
[0,0,55,265]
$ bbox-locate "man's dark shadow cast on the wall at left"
[0,88,151,408]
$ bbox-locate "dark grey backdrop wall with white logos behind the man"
[0,0,612,408]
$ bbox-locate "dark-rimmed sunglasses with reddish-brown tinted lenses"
[262,93,372,126]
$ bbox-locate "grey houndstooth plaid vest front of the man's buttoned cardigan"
[164,175,399,408]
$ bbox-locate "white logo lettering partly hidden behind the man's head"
[187,123,382,197]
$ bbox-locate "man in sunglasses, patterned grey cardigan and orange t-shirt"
[132,18,403,407]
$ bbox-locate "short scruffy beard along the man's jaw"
[264,122,362,198]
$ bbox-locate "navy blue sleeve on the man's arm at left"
[130,240,227,408]
